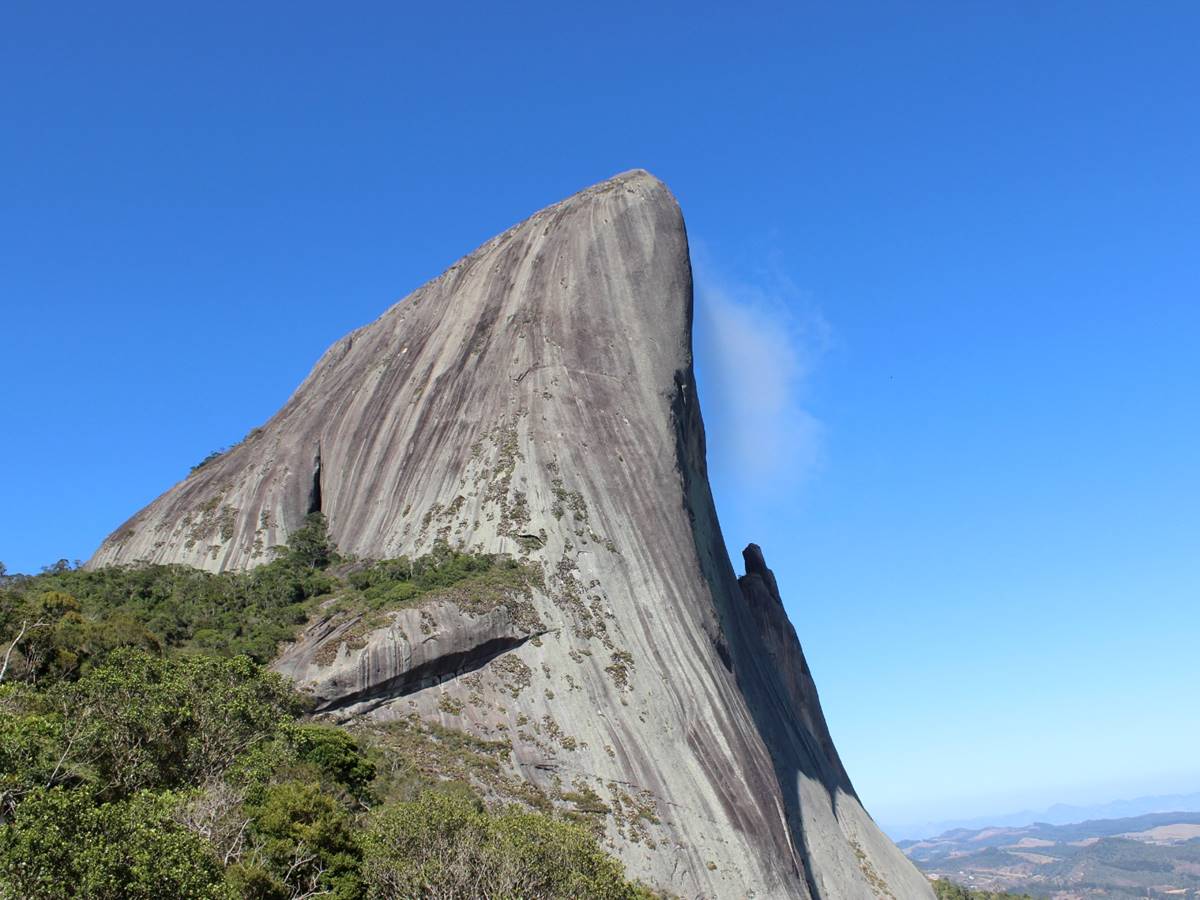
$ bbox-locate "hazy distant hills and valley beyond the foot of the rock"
[899,812,1200,900]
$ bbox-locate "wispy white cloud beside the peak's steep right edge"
[696,258,830,493]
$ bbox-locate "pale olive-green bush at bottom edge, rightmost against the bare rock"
[364,791,644,900]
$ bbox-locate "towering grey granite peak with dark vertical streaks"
[90,172,932,900]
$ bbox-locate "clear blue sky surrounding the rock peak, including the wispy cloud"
[0,2,1200,823]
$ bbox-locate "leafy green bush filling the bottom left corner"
[0,788,234,900]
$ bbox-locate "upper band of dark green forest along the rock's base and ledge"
[0,512,535,683]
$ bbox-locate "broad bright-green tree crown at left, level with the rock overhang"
[0,649,302,812]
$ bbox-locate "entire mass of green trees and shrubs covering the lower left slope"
[0,518,649,900]
